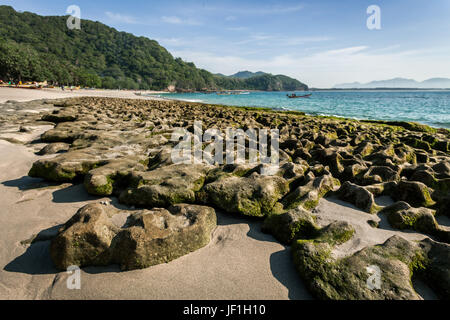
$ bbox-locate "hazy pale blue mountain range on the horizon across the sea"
[333,78,450,89]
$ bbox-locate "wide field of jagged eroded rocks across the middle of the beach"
[29,98,450,220]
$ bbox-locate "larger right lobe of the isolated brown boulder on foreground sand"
[113,204,217,270]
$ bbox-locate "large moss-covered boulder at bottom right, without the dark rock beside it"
[292,236,420,300]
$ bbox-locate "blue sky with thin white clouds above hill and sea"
[0,0,450,88]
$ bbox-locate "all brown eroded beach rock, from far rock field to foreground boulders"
[5,97,450,299]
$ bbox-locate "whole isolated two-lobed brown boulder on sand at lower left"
[50,204,216,270]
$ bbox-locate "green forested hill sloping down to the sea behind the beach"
[0,6,307,90]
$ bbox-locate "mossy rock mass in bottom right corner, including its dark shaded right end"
[292,229,450,300]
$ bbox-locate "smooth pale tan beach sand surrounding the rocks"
[0,88,435,299]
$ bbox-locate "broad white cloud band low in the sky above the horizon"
[174,46,450,88]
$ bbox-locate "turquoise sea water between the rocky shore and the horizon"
[156,90,450,128]
